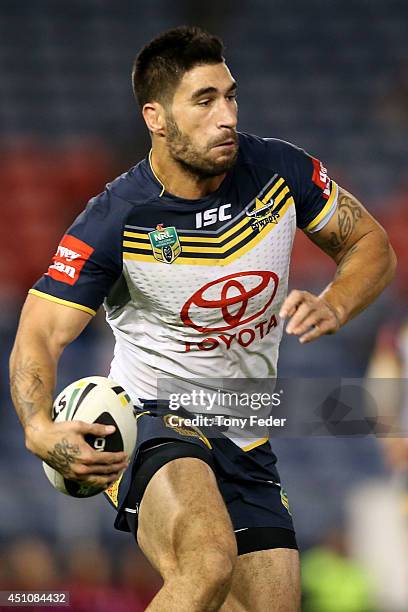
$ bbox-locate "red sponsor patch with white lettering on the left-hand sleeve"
[47,234,94,285]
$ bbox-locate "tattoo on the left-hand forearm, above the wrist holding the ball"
[10,357,50,427]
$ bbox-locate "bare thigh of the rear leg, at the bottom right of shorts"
[221,548,300,612]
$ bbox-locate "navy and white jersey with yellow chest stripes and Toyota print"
[30,133,338,444]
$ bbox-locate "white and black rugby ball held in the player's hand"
[43,376,136,497]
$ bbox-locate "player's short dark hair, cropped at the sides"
[132,26,224,108]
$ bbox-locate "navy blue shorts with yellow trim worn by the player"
[105,402,297,554]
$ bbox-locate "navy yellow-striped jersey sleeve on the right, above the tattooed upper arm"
[270,143,338,233]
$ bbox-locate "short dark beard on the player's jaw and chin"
[166,113,238,179]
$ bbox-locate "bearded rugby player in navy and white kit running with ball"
[11,27,395,612]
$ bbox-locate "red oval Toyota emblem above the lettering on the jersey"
[180,270,279,332]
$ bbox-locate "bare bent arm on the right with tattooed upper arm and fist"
[280,188,396,343]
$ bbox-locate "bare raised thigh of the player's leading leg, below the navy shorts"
[137,457,237,579]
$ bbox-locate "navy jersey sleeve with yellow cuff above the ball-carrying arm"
[29,189,126,315]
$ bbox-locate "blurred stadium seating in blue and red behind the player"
[0,0,408,612]
